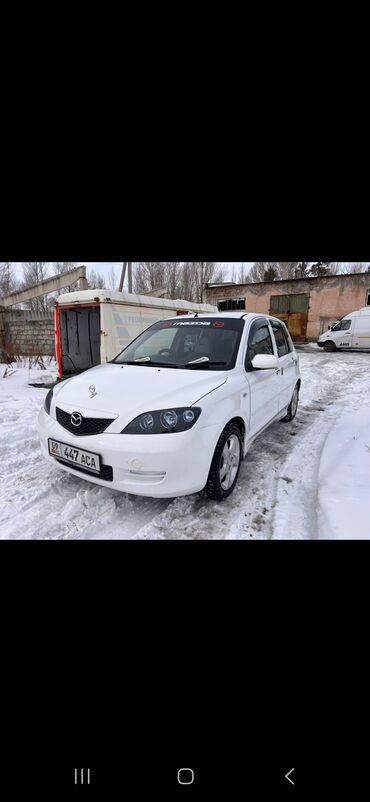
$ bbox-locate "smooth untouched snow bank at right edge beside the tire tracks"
[318,407,370,539]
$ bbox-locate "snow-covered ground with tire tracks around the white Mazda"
[0,346,370,540]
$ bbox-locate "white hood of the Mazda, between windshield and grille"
[53,364,227,426]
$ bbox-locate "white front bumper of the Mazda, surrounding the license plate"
[38,409,220,498]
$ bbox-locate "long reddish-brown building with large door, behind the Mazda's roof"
[203,273,370,340]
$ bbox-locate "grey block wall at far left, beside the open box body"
[0,309,55,356]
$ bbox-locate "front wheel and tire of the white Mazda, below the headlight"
[204,423,243,501]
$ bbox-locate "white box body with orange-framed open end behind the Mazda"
[55,290,217,379]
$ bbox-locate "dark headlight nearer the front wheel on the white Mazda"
[121,407,202,434]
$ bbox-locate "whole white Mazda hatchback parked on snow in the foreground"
[38,312,301,500]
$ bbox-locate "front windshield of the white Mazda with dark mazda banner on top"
[113,317,244,370]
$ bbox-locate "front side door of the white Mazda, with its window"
[244,318,280,436]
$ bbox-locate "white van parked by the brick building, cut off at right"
[317,306,370,351]
